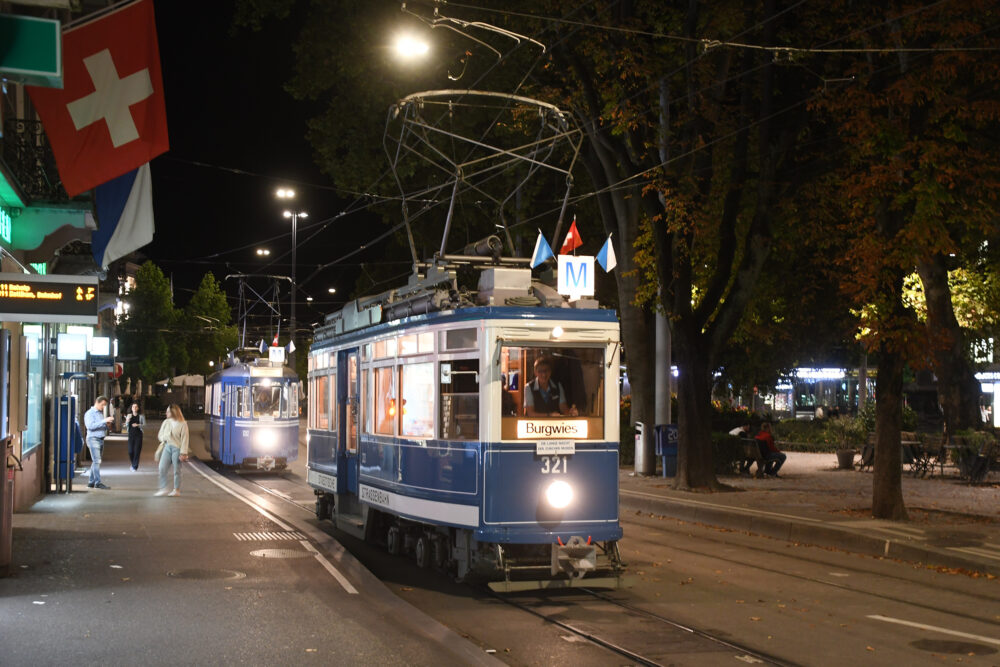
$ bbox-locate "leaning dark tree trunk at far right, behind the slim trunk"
[917,255,981,433]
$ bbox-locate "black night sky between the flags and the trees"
[142,0,353,324]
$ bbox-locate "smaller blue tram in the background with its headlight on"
[205,359,299,470]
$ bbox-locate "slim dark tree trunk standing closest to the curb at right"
[872,343,908,521]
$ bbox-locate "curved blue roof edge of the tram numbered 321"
[313,306,618,347]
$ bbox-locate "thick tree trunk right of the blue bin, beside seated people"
[674,323,722,491]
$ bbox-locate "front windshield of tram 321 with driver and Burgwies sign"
[498,346,605,439]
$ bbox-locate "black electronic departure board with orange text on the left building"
[0,273,98,324]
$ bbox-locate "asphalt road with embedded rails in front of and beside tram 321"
[195,422,1000,665]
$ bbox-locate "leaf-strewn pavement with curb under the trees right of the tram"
[619,452,1000,576]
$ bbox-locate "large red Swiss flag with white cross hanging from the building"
[28,0,169,197]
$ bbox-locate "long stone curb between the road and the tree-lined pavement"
[619,490,1000,576]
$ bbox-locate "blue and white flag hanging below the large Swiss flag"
[90,162,153,269]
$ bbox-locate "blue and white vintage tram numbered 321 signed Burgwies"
[307,269,622,590]
